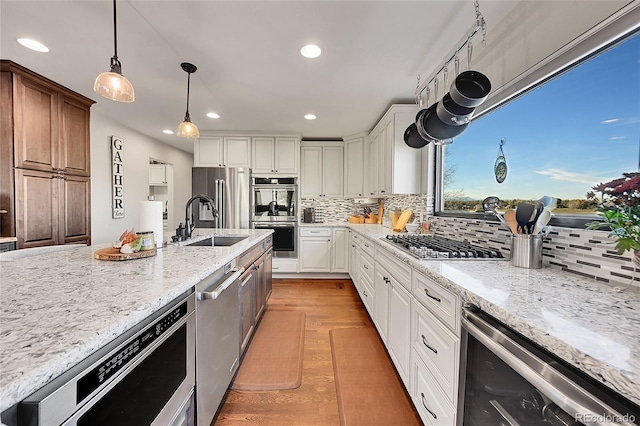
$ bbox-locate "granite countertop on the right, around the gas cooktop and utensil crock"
[348,224,640,404]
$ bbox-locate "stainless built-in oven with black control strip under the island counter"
[18,293,195,426]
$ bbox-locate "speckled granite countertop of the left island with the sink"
[0,229,273,412]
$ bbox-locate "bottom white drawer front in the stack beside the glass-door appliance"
[411,353,456,426]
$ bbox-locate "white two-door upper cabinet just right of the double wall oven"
[300,142,344,198]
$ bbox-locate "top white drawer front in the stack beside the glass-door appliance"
[413,272,460,336]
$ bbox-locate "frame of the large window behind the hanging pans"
[433,4,640,229]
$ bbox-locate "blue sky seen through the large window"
[445,34,640,200]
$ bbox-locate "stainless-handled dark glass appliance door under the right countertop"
[458,309,640,426]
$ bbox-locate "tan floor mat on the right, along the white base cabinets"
[329,327,422,426]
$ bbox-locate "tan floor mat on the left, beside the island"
[231,309,306,391]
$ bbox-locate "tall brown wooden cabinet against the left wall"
[0,61,94,248]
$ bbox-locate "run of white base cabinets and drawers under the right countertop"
[349,231,460,426]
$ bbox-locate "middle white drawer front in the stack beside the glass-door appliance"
[411,300,460,403]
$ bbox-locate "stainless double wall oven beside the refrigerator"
[250,177,298,258]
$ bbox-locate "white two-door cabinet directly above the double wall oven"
[251,137,299,175]
